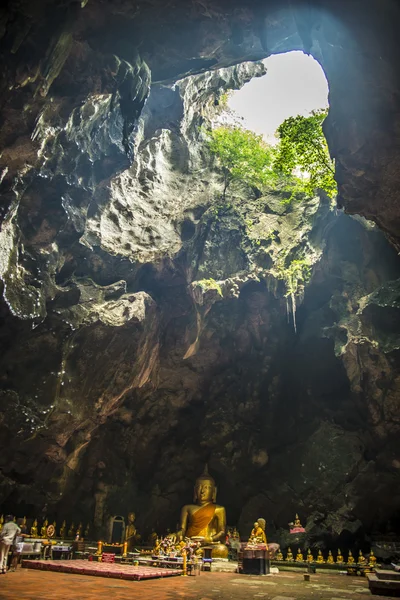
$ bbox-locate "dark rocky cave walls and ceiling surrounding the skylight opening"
[0,0,400,564]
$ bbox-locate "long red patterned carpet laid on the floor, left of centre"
[22,560,182,581]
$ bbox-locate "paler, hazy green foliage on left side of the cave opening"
[208,125,272,198]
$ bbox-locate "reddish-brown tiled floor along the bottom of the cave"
[0,568,388,600]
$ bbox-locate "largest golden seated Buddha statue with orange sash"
[177,467,228,557]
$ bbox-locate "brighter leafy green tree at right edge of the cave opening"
[272,110,337,200]
